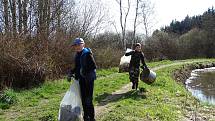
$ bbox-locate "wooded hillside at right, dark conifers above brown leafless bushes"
[145,7,215,60]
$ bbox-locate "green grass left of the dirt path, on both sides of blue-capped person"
[0,68,129,121]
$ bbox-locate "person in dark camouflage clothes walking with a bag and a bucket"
[125,43,147,90]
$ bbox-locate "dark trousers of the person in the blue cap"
[79,79,95,121]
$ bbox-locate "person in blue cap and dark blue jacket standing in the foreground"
[69,38,96,121]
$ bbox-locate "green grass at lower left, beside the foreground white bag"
[0,80,69,121]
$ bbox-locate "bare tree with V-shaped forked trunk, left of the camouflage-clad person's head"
[116,0,130,49]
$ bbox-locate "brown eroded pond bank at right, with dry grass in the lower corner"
[173,62,215,121]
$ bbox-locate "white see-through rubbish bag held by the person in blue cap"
[58,80,82,121]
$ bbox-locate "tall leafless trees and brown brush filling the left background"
[0,0,111,90]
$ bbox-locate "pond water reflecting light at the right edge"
[186,67,215,105]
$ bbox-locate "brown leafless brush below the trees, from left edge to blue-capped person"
[0,36,72,90]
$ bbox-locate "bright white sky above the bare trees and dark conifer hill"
[103,0,215,34]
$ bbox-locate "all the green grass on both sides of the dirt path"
[0,59,214,121]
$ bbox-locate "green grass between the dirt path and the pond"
[98,60,215,121]
